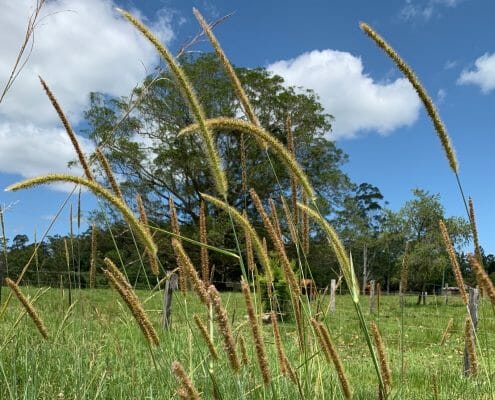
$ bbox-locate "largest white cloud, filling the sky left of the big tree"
[0,0,173,188]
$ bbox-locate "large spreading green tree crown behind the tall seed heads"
[85,54,350,278]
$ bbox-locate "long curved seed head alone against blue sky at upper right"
[359,22,459,175]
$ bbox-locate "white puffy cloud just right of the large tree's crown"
[268,50,420,139]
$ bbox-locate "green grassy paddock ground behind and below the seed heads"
[0,288,495,399]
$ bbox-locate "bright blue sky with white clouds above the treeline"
[0,0,495,253]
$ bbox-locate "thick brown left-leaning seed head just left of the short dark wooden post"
[103,258,159,346]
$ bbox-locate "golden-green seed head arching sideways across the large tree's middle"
[179,117,316,200]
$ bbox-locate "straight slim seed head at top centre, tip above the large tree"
[193,8,260,126]
